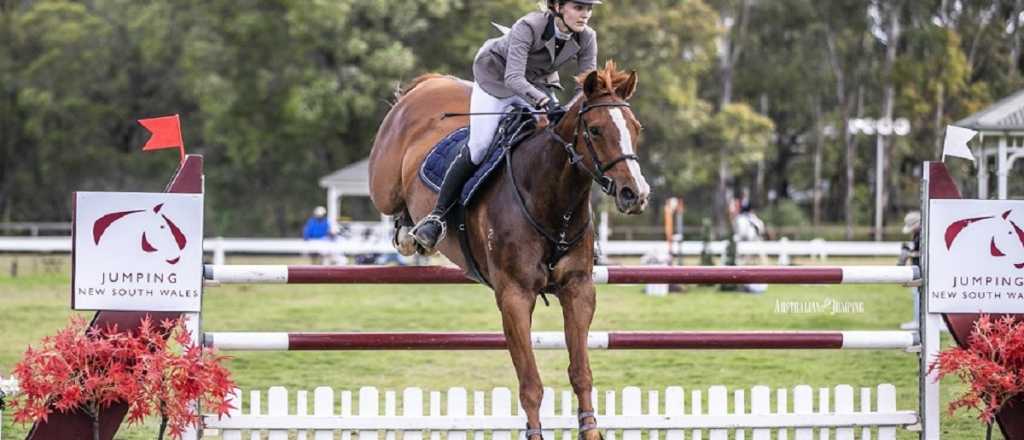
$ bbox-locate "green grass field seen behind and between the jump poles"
[0,255,1001,440]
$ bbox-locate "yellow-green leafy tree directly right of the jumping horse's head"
[593,0,720,220]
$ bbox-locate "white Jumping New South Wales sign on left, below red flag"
[72,191,203,312]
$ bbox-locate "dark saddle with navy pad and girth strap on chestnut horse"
[420,105,537,289]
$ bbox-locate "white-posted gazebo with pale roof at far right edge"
[953,90,1024,199]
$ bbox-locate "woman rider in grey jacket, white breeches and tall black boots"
[410,0,601,250]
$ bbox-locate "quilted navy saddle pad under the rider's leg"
[420,127,505,206]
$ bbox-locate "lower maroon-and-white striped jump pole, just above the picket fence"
[204,332,918,351]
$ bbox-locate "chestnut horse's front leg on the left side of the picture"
[496,287,544,440]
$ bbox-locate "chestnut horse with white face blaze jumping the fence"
[370,60,650,440]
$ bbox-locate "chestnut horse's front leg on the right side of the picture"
[559,273,601,440]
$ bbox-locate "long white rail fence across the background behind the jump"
[0,236,900,264]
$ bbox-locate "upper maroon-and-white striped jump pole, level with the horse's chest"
[204,265,921,284]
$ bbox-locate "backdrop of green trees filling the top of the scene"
[0,0,1024,236]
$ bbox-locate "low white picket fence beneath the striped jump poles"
[205,384,919,440]
